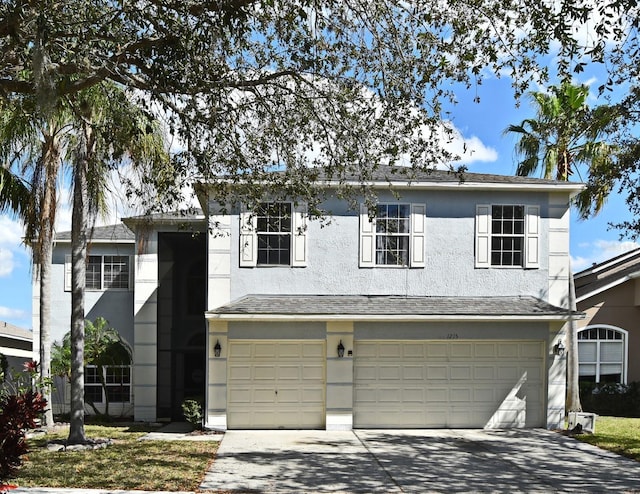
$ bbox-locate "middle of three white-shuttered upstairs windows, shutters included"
[360,203,426,268]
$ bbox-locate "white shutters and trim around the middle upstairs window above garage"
[358,202,427,268]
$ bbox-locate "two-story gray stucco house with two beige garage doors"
[36,167,581,430]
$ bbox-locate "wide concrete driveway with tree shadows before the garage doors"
[200,429,640,493]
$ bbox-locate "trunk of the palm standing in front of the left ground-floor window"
[68,121,94,444]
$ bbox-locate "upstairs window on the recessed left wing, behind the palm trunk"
[65,255,131,291]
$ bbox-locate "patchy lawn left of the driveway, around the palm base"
[12,425,218,491]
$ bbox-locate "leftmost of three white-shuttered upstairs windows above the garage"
[240,201,307,267]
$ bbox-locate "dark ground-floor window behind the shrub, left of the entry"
[84,365,131,403]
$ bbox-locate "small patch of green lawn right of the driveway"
[576,417,640,461]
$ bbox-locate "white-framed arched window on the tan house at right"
[578,324,627,384]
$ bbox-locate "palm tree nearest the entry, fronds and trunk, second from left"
[68,83,168,444]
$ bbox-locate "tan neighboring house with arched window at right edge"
[574,249,640,384]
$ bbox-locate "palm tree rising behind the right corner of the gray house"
[504,81,616,412]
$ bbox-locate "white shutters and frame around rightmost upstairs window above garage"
[475,203,540,269]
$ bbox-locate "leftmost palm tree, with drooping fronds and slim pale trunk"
[0,97,70,425]
